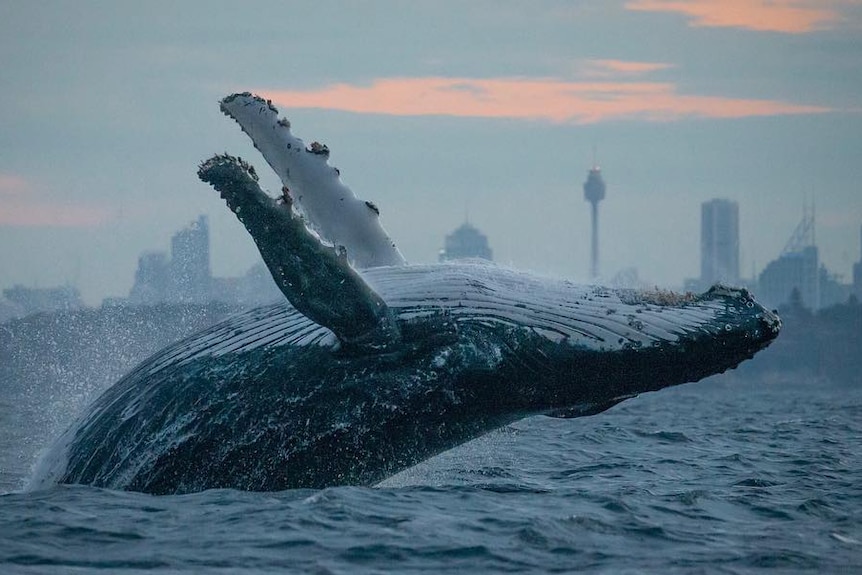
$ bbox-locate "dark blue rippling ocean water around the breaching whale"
[0,376,862,574]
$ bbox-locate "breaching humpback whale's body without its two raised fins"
[37,264,777,493]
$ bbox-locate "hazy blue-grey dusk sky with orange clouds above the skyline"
[0,0,862,305]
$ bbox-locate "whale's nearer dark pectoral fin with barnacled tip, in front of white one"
[198,155,399,351]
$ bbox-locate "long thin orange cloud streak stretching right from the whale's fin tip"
[262,77,831,124]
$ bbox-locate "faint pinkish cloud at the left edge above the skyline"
[0,174,112,228]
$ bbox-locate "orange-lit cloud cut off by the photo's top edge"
[626,0,858,34]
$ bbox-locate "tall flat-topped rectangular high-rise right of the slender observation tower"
[700,199,739,286]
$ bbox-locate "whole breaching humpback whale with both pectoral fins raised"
[34,93,781,494]
